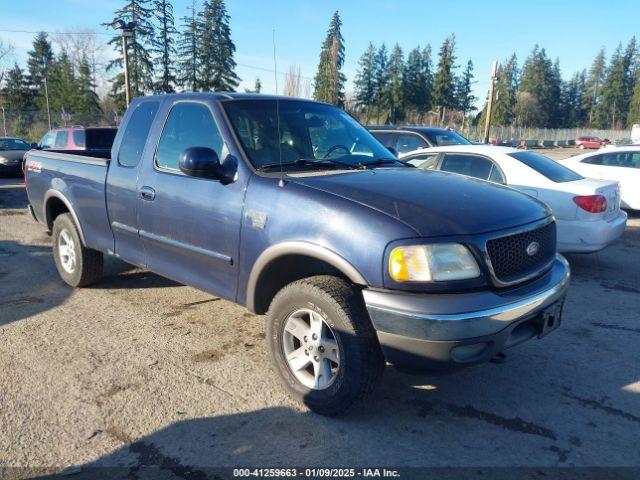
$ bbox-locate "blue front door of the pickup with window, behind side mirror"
[139,100,247,299]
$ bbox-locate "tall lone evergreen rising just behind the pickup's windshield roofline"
[313,11,346,108]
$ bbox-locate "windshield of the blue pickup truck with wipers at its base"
[223,99,403,171]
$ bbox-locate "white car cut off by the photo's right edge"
[560,145,640,210]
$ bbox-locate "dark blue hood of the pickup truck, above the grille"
[288,168,551,237]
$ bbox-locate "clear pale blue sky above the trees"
[0,0,640,106]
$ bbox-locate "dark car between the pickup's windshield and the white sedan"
[367,126,471,155]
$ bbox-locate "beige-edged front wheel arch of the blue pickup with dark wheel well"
[246,242,367,314]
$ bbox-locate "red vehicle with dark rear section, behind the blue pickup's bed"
[37,126,118,150]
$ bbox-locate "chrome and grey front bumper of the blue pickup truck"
[363,255,570,370]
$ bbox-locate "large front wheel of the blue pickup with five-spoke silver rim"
[267,276,384,416]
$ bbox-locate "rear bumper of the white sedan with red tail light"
[556,210,627,253]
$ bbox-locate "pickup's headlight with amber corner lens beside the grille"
[389,243,480,282]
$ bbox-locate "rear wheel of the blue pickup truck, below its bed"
[51,213,103,287]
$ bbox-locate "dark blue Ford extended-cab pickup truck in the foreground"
[25,93,569,415]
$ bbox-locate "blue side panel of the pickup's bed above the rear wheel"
[24,150,113,252]
